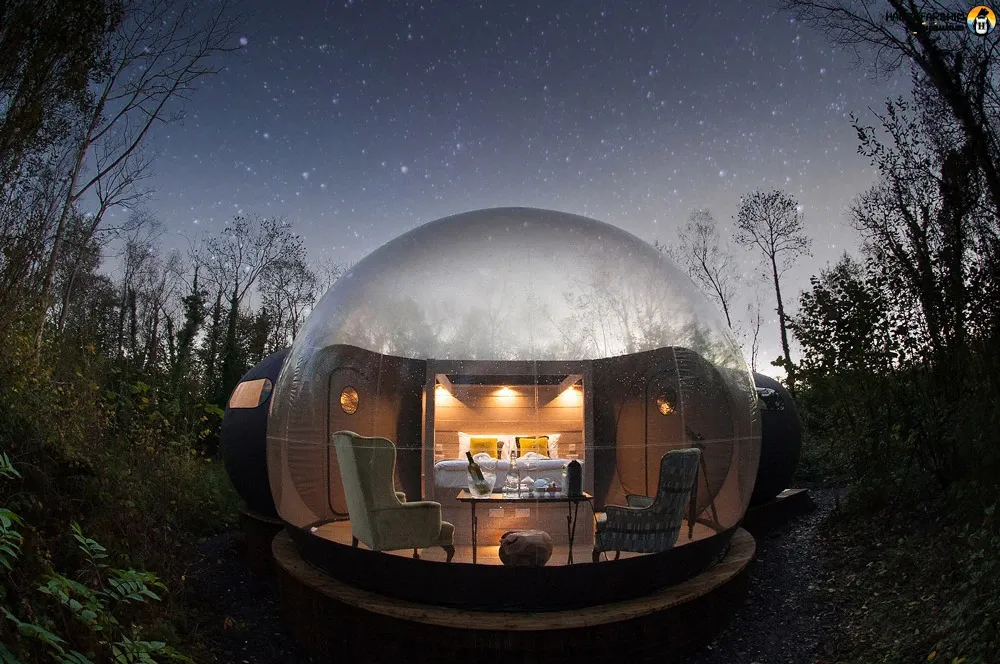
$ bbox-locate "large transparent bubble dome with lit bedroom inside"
[267,208,760,610]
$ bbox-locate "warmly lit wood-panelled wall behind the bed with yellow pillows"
[434,385,584,461]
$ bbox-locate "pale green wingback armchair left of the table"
[333,431,455,562]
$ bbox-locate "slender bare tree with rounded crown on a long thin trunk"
[734,189,810,384]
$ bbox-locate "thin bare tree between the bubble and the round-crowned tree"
[676,210,736,329]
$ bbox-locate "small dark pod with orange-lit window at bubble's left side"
[219,348,289,517]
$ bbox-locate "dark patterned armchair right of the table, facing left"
[593,448,701,563]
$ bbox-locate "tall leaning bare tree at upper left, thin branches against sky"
[36,0,238,348]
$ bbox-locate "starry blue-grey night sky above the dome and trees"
[121,0,908,370]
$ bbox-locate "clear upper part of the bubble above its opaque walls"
[282,208,744,370]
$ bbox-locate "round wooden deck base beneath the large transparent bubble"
[272,529,756,664]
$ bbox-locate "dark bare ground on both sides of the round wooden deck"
[189,490,842,664]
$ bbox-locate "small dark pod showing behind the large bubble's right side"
[750,373,802,506]
